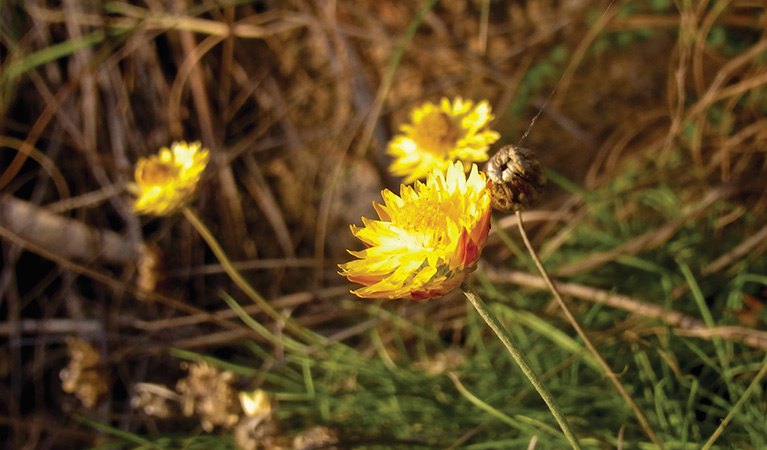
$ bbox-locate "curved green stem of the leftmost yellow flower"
[182,207,325,344]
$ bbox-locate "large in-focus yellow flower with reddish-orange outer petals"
[339,161,491,300]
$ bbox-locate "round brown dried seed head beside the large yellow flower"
[485,145,546,212]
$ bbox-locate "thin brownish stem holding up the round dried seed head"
[517,211,664,450]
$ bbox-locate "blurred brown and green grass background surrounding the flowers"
[0,0,767,449]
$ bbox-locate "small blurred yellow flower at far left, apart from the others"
[131,142,210,216]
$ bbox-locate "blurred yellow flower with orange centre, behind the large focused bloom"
[386,97,500,183]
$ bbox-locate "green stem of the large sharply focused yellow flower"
[461,283,583,450]
